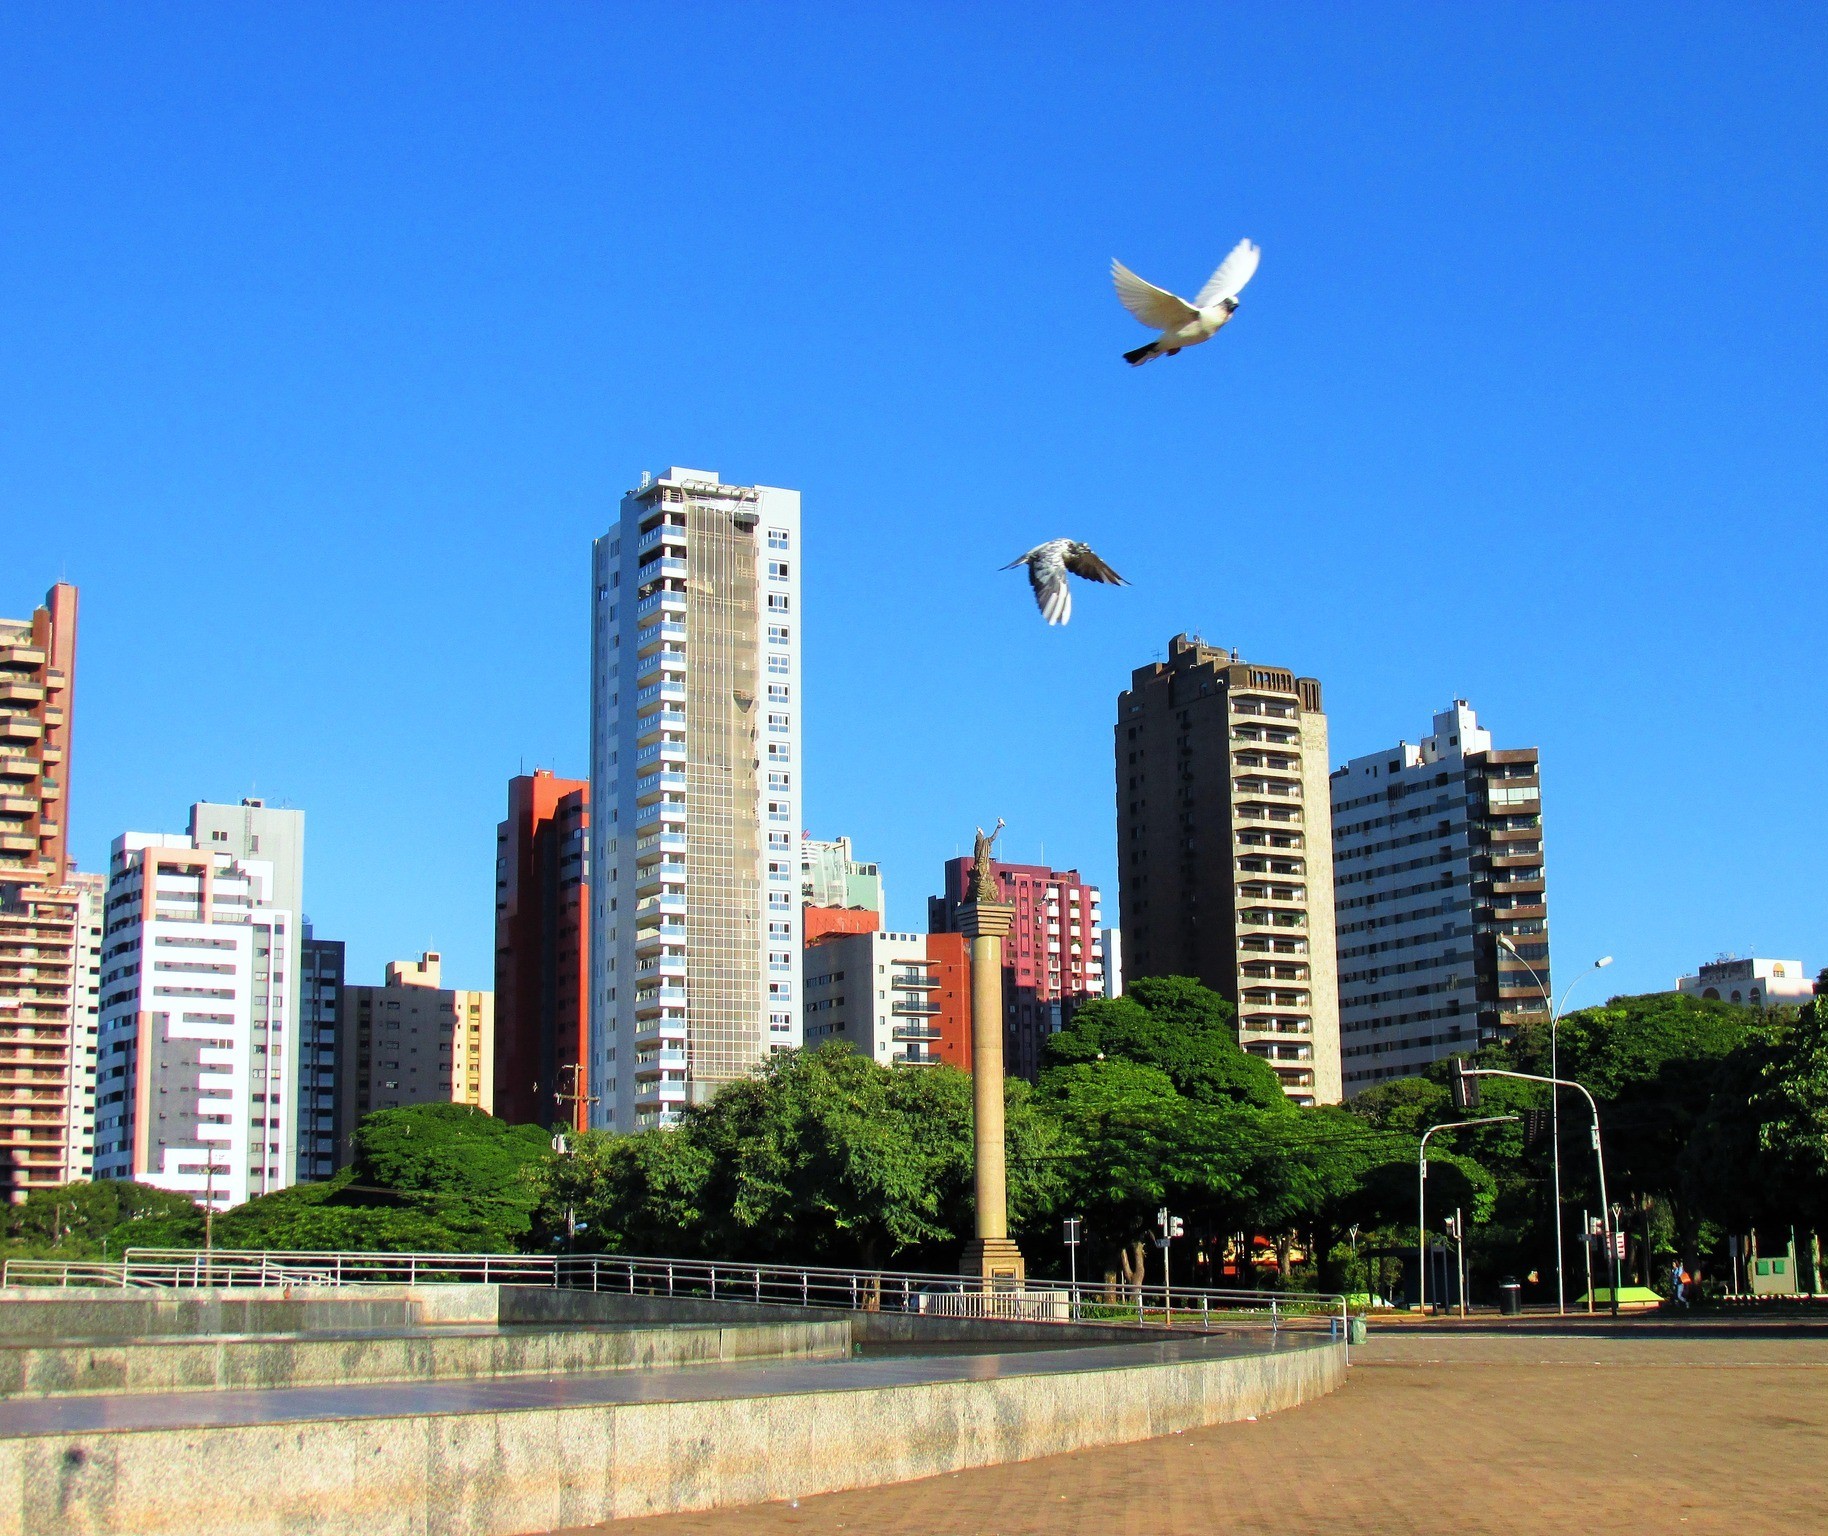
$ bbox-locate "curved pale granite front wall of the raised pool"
[0,1335,1345,1536]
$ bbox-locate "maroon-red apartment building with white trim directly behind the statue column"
[927,858,1104,1083]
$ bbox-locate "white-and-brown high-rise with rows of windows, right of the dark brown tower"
[1331,699,1552,1093]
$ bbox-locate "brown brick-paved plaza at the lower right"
[598,1328,1828,1536]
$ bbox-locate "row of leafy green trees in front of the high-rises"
[7,978,1828,1289]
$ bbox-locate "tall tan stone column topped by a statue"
[958,821,1027,1291]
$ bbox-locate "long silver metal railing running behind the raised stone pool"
[4,1247,1349,1337]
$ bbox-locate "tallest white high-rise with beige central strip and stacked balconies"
[590,468,802,1130]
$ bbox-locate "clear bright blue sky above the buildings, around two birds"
[0,4,1828,991]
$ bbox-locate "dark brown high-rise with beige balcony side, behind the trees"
[1115,635,1340,1104]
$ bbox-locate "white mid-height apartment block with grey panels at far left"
[95,833,298,1209]
